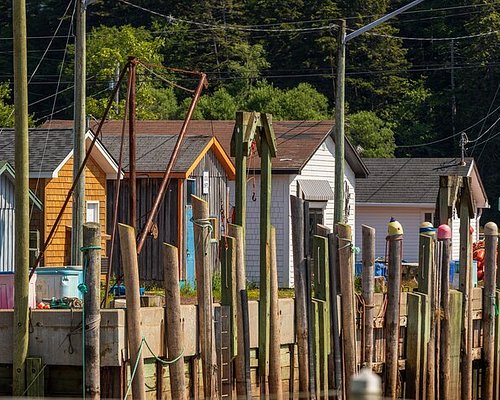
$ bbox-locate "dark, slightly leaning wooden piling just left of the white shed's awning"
[290,196,309,393]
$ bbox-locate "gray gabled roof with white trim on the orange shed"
[0,128,118,178]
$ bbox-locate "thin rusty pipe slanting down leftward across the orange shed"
[30,63,129,279]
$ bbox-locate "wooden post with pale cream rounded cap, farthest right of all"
[483,222,498,399]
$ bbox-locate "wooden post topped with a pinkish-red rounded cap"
[438,225,451,399]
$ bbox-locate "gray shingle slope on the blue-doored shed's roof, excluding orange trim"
[102,135,212,172]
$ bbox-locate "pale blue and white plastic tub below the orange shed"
[36,266,83,303]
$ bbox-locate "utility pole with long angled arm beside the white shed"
[333,0,424,227]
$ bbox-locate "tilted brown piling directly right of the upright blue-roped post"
[118,224,146,400]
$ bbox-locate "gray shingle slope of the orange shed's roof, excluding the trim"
[0,129,73,177]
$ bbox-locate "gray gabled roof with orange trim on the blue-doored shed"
[102,135,234,179]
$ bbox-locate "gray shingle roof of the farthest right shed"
[356,158,472,203]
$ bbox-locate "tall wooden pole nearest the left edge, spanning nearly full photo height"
[12,0,30,396]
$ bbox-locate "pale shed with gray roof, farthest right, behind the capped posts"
[356,158,489,262]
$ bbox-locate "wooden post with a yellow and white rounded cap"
[385,219,403,399]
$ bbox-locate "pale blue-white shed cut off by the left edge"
[0,161,42,272]
